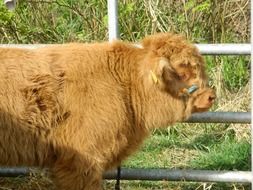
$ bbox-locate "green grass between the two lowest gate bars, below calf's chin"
[124,124,251,170]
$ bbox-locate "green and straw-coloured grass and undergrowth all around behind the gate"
[0,0,251,190]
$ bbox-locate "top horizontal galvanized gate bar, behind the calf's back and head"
[0,44,251,55]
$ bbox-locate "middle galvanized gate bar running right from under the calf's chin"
[186,112,251,124]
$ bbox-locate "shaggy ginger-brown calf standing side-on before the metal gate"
[0,33,215,190]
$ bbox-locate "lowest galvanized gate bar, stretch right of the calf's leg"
[104,168,252,183]
